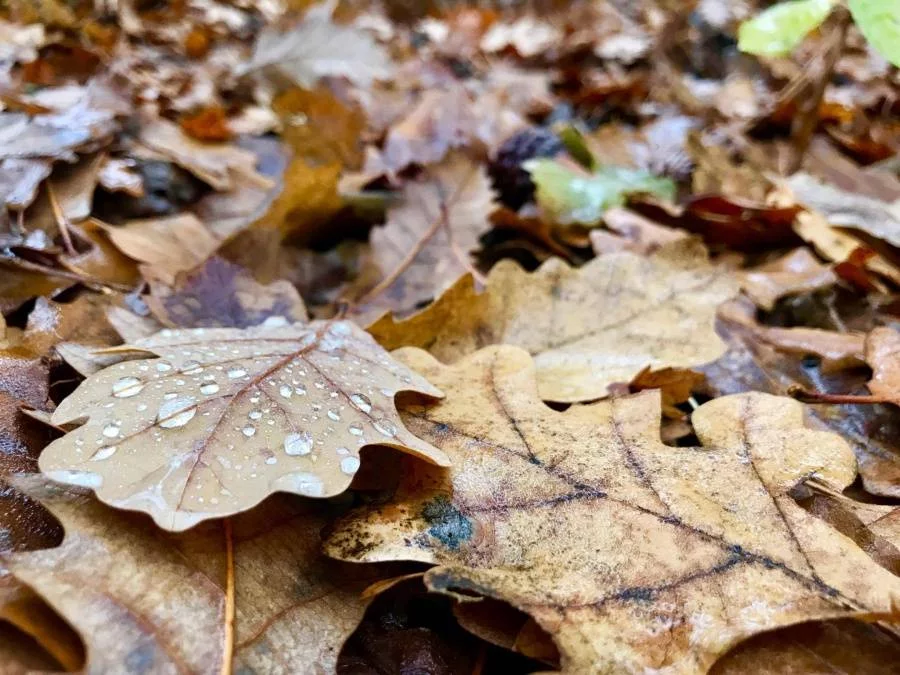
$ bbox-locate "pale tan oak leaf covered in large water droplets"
[39,321,447,531]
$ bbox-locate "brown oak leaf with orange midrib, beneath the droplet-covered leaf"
[6,477,388,674]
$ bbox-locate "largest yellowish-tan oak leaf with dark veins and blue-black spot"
[325,346,900,673]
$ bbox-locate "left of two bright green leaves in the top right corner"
[738,0,836,56]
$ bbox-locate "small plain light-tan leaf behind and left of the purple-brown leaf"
[102,213,221,285]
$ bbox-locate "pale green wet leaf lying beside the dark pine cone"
[523,159,675,225]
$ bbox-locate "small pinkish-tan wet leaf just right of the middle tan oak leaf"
[738,248,837,311]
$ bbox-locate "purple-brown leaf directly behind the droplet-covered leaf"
[147,256,309,328]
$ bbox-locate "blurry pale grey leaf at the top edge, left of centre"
[242,0,393,89]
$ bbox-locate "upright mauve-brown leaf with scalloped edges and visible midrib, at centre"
[351,155,494,322]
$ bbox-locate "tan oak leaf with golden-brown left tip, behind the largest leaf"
[369,241,736,402]
